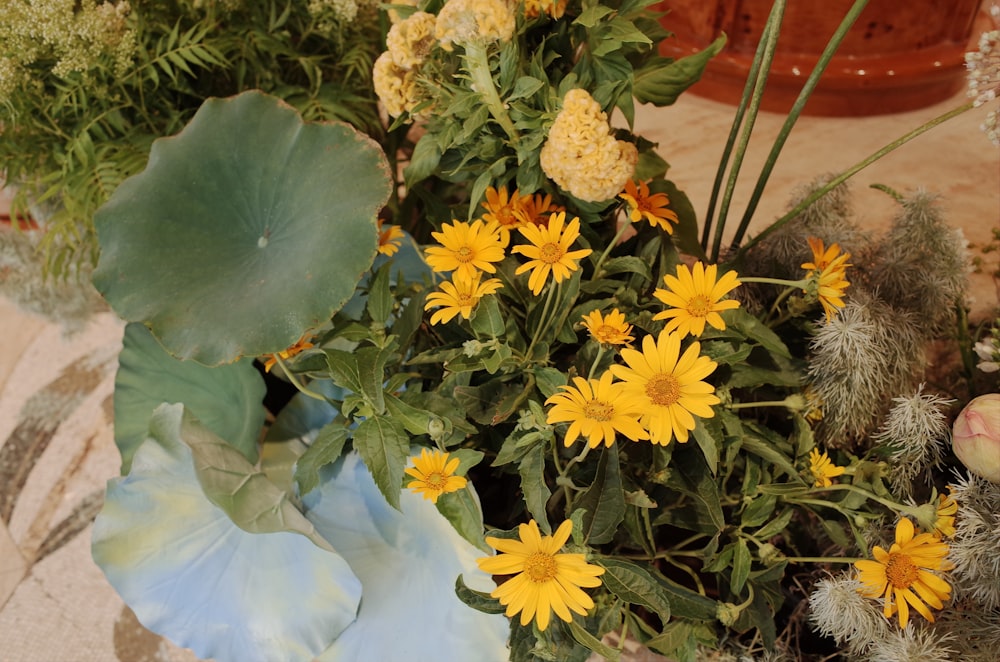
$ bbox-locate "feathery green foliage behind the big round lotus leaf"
[0,0,381,276]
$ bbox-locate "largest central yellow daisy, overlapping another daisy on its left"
[611,331,720,446]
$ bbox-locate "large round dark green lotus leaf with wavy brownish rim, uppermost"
[93,91,390,365]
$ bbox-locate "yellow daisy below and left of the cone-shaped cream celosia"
[513,212,593,295]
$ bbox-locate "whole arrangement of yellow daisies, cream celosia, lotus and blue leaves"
[72,0,1000,662]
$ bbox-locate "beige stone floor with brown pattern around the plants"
[0,81,1000,662]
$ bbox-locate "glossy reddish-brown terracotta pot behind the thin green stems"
[658,0,989,115]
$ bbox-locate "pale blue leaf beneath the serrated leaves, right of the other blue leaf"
[304,453,508,662]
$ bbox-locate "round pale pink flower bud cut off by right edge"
[951,393,1000,483]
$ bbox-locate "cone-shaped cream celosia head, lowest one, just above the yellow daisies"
[539,89,639,202]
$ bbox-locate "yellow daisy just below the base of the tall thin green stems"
[653,262,742,338]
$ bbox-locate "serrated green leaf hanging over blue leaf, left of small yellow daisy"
[354,416,410,510]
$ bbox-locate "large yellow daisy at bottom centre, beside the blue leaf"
[476,520,604,631]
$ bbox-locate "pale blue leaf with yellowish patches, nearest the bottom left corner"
[92,405,361,662]
